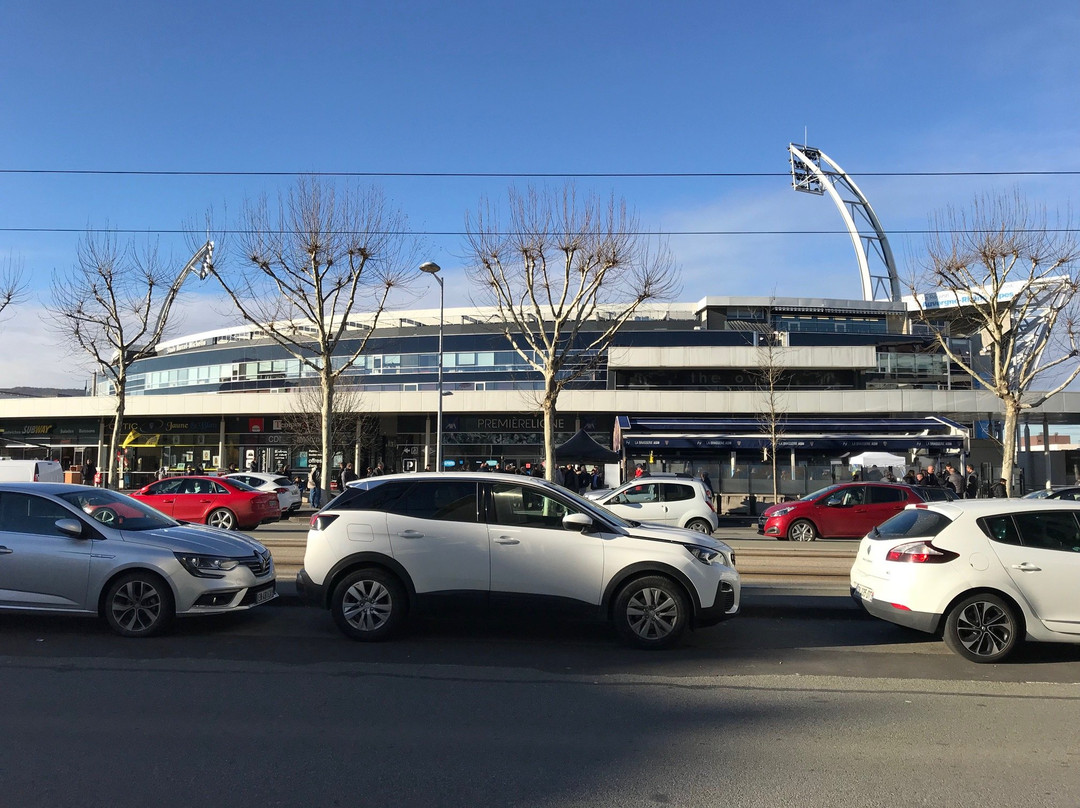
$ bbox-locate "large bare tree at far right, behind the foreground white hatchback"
[913,192,1080,493]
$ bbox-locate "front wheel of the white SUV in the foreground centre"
[615,576,690,648]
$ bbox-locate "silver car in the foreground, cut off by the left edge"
[0,483,276,637]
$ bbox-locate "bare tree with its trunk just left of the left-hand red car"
[45,233,178,487]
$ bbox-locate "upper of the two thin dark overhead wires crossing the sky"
[0,169,1080,179]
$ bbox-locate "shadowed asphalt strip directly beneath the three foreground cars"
[0,605,1080,683]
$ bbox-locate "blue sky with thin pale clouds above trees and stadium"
[0,0,1080,387]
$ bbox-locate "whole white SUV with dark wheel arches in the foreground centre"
[296,473,740,648]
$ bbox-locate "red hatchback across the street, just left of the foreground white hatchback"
[757,483,947,541]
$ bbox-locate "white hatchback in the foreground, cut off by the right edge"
[851,499,1080,662]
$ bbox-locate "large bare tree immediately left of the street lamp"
[209,177,419,501]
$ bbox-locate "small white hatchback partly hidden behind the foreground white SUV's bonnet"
[585,476,719,534]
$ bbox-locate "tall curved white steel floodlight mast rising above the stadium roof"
[787,144,901,300]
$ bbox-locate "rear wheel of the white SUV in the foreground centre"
[330,567,408,643]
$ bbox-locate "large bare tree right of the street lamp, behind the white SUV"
[465,186,678,480]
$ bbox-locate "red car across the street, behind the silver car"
[132,476,281,530]
